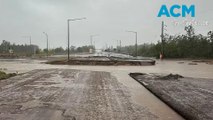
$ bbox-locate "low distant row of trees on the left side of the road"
[0,40,95,58]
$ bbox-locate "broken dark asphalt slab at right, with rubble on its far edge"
[130,73,213,120]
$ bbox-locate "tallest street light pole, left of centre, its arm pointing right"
[67,17,86,61]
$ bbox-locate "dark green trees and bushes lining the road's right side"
[118,25,213,59]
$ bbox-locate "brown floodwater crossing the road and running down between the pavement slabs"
[0,60,213,120]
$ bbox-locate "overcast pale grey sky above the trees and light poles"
[0,0,213,48]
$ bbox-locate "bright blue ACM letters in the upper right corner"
[158,4,195,17]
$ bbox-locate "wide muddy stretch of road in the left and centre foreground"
[0,69,158,120]
